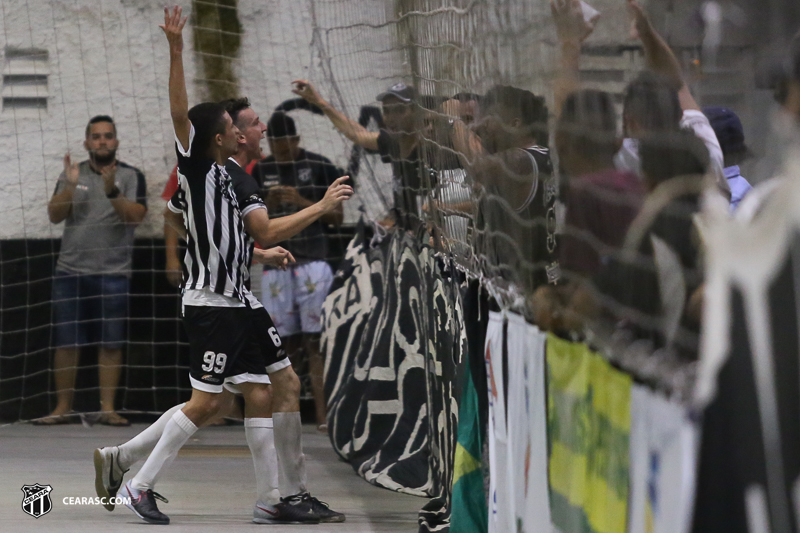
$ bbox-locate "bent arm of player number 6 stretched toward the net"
[244,176,353,248]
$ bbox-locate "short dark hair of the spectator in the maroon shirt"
[556,89,618,158]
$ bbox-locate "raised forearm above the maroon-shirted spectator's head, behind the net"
[550,0,600,116]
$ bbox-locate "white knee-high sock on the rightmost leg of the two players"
[272,411,306,498]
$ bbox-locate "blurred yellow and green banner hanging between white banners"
[547,335,631,533]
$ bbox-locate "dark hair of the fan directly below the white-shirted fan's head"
[639,130,710,183]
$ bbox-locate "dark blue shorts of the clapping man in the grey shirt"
[53,270,130,349]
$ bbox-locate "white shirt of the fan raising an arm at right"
[614,109,730,191]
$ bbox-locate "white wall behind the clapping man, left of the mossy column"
[0,0,203,239]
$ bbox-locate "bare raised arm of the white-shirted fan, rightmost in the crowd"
[626,0,700,111]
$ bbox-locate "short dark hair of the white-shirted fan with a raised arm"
[622,71,683,131]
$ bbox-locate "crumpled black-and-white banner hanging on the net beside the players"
[321,223,466,530]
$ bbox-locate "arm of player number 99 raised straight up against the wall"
[158,6,192,151]
